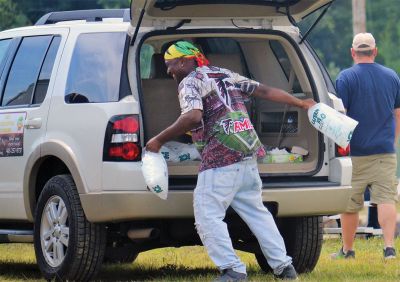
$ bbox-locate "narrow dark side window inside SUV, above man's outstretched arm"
[269,40,303,93]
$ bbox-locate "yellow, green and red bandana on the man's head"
[164,41,209,67]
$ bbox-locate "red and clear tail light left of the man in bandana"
[103,115,142,162]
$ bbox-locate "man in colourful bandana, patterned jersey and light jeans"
[146,41,315,281]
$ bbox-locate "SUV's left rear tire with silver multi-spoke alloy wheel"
[34,175,106,281]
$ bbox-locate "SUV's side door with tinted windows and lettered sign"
[0,28,69,219]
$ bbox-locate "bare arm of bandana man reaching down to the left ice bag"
[146,109,203,153]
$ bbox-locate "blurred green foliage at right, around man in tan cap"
[301,0,400,79]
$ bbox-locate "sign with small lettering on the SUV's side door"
[0,112,26,157]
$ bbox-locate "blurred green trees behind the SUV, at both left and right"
[0,0,400,79]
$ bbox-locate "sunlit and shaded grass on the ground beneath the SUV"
[0,238,400,282]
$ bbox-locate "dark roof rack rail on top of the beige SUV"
[35,9,131,25]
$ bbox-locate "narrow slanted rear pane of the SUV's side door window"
[32,36,61,104]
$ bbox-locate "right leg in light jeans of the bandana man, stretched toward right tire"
[231,160,292,274]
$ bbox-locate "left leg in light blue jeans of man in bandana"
[194,164,246,273]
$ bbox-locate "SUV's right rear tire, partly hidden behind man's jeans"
[255,216,323,273]
